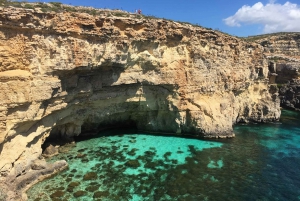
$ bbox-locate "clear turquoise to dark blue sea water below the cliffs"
[28,111,300,201]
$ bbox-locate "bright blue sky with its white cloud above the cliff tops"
[28,0,300,37]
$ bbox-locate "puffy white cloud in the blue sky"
[223,0,300,33]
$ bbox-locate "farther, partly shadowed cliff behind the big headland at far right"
[253,33,300,110]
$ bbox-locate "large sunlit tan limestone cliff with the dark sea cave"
[0,8,280,175]
